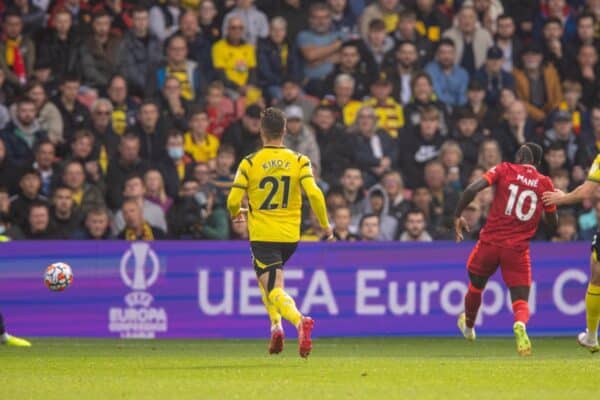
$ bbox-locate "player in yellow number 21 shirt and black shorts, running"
[227,108,333,357]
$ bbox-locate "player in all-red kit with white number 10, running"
[454,143,558,355]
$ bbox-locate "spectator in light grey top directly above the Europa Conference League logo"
[112,175,167,234]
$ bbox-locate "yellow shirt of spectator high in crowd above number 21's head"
[212,39,256,86]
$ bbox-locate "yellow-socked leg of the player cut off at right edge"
[577,239,600,353]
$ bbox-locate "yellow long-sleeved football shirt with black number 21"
[227,146,329,243]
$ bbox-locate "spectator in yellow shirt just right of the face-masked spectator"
[183,109,219,164]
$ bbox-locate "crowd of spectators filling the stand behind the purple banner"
[0,0,600,241]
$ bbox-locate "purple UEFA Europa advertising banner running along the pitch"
[0,241,589,338]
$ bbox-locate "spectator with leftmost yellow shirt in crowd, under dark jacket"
[107,75,138,136]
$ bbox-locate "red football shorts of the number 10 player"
[467,242,531,288]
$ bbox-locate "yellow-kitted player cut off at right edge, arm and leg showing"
[542,154,600,353]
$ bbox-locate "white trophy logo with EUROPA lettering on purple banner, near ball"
[108,242,167,339]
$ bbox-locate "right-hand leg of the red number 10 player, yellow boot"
[500,248,531,356]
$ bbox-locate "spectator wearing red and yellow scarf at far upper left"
[0,11,35,87]
